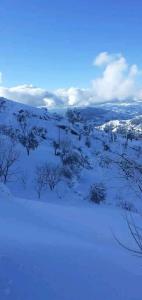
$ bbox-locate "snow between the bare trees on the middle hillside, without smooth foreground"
[0,98,142,211]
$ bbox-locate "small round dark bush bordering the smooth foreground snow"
[89,183,106,204]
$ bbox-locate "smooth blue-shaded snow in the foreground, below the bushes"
[0,187,142,300]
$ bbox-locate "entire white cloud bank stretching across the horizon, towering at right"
[0,52,142,108]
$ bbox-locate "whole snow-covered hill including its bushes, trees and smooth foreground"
[0,98,142,300]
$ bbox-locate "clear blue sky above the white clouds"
[0,0,142,90]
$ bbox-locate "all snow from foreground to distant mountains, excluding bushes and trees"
[0,99,142,300]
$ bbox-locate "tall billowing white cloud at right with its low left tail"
[56,52,142,106]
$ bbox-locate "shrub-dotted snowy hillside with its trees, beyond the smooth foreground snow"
[0,98,142,211]
